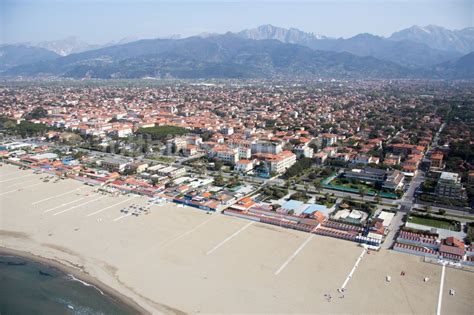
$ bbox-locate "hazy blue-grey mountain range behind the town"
[0,25,474,79]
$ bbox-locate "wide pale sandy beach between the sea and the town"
[0,165,474,314]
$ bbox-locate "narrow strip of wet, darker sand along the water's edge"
[0,246,152,314]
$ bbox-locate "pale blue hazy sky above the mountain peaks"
[0,0,474,43]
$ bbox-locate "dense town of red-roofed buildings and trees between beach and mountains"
[0,81,474,266]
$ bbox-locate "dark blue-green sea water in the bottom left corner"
[0,255,137,315]
